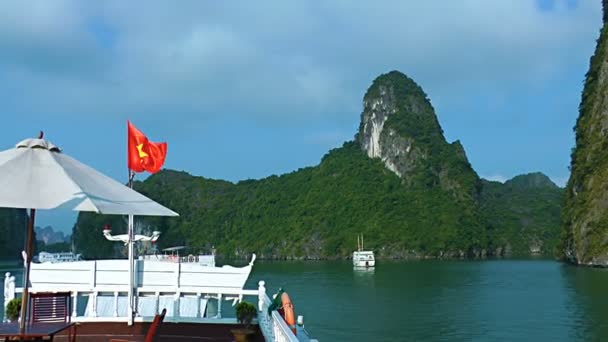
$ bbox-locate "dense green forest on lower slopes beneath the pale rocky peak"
[75,142,485,258]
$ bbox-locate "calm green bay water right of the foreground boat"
[247,260,608,341]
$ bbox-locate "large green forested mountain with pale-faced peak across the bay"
[74,71,559,258]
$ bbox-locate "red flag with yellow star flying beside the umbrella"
[127,121,167,173]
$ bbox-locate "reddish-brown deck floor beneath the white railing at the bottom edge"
[48,322,264,342]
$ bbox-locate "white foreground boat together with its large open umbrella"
[0,133,318,342]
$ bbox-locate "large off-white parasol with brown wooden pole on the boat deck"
[0,134,178,324]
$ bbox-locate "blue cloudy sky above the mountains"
[0,0,602,231]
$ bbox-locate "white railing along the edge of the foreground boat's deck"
[4,272,317,342]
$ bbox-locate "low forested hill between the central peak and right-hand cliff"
[480,173,563,255]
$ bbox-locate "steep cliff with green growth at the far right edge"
[560,1,608,266]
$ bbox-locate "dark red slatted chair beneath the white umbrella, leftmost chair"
[28,292,76,342]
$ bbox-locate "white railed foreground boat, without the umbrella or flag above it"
[4,246,315,342]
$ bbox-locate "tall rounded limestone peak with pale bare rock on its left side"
[357,71,480,198]
